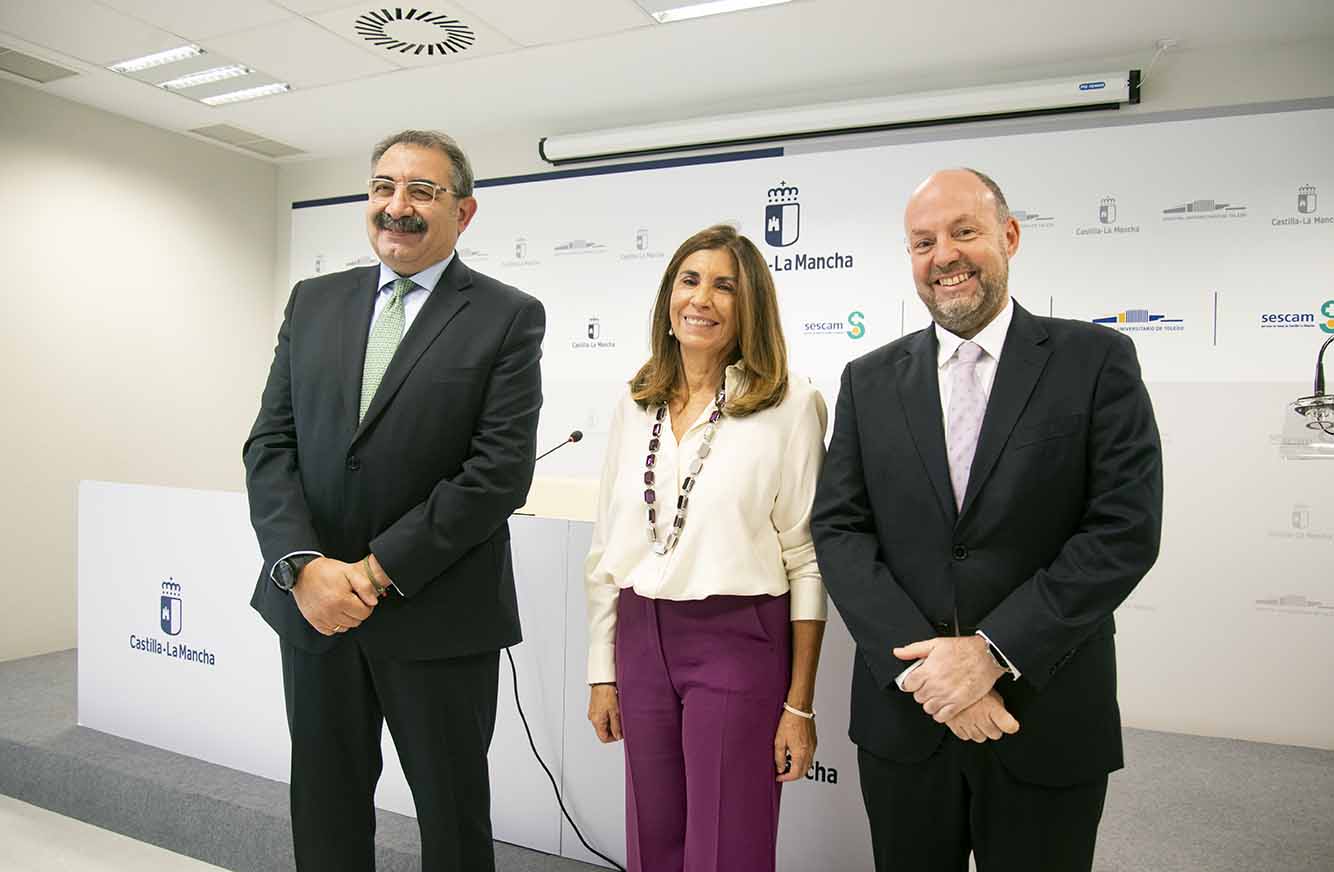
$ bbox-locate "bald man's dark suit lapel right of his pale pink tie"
[959,303,1051,517]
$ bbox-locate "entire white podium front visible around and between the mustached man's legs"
[79,481,568,853]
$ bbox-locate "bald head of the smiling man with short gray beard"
[903,168,1019,339]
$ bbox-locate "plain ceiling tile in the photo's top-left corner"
[0,0,185,67]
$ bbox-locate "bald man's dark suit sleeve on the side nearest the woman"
[811,364,936,689]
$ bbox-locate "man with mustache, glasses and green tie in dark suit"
[243,131,546,872]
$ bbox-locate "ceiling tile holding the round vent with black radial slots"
[312,1,519,67]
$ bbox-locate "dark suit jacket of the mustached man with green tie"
[243,256,546,659]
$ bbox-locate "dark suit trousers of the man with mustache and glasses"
[280,636,500,872]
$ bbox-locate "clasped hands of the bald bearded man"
[894,636,1019,741]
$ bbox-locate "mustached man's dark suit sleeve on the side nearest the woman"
[371,300,547,596]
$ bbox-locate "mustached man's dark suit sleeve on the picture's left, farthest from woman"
[241,283,323,571]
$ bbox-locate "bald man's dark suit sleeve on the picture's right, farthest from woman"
[980,335,1163,689]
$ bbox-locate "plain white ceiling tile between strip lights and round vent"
[204,19,399,88]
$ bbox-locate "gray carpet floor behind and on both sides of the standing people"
[0,651,1334,872]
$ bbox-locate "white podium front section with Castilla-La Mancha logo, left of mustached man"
[79,481,289,780]
